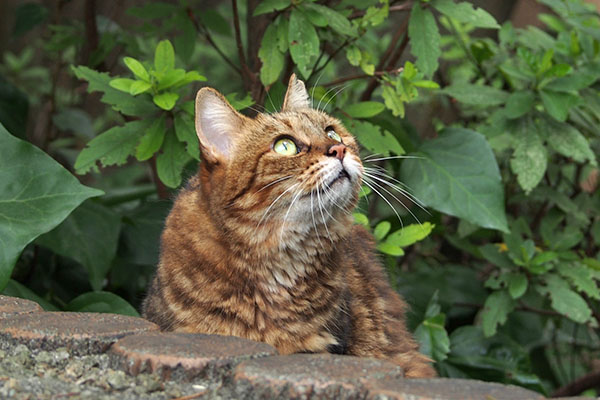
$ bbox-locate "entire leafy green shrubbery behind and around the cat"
[0,0,600,396]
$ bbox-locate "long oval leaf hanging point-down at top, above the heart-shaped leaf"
[408,2,442,77]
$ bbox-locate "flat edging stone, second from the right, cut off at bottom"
[233,354,403,399]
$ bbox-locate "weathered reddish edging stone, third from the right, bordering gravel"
[109,332,277,379]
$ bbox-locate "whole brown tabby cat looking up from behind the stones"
[143,76,435,377]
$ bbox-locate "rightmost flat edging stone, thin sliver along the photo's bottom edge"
[365,378,545,400]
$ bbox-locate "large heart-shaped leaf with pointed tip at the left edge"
[0,124,102,290]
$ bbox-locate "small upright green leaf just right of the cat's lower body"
[415,313,450,362]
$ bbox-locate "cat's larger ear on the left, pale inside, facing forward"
[196,88,246,163]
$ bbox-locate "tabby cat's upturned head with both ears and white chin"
[196,75,363,244]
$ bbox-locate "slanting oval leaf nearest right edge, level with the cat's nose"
[542,120,597,166]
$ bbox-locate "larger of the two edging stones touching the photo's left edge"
[0,312,158,355]
